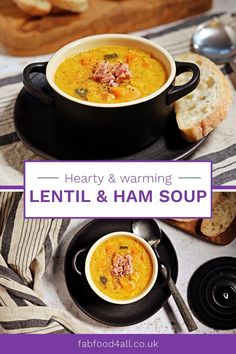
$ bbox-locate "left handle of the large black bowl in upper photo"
[23,62,54,106]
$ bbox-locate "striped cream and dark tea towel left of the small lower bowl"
[0,193,86,334]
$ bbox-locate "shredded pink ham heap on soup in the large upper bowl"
[93,61,131,87]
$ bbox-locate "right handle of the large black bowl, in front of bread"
[167,61,200,104]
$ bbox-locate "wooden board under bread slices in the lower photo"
[165,219,236,246]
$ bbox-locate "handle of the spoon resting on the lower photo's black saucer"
[163,269,197,332]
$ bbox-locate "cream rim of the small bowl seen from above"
[85,231,158,305]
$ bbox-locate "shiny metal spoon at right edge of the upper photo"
[192,18,236,73]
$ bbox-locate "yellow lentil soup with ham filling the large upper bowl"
[55,46,167,103]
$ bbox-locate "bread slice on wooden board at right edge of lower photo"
[201,192,236,237]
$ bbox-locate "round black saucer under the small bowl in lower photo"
[65,219,178,326]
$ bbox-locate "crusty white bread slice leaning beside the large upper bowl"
[175,53,232,142]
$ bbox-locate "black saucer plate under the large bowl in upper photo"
[14,74,204,160]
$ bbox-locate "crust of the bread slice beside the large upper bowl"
[175,53,233,142]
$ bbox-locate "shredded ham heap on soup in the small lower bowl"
[111,253,133,277]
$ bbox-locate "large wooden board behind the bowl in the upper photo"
[0,0,212,56]
